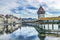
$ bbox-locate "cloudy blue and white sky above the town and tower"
[0,0,60,18]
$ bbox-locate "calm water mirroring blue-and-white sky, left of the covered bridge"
[0,27,40,40]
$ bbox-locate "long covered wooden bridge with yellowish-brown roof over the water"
[22,17,60,34]
